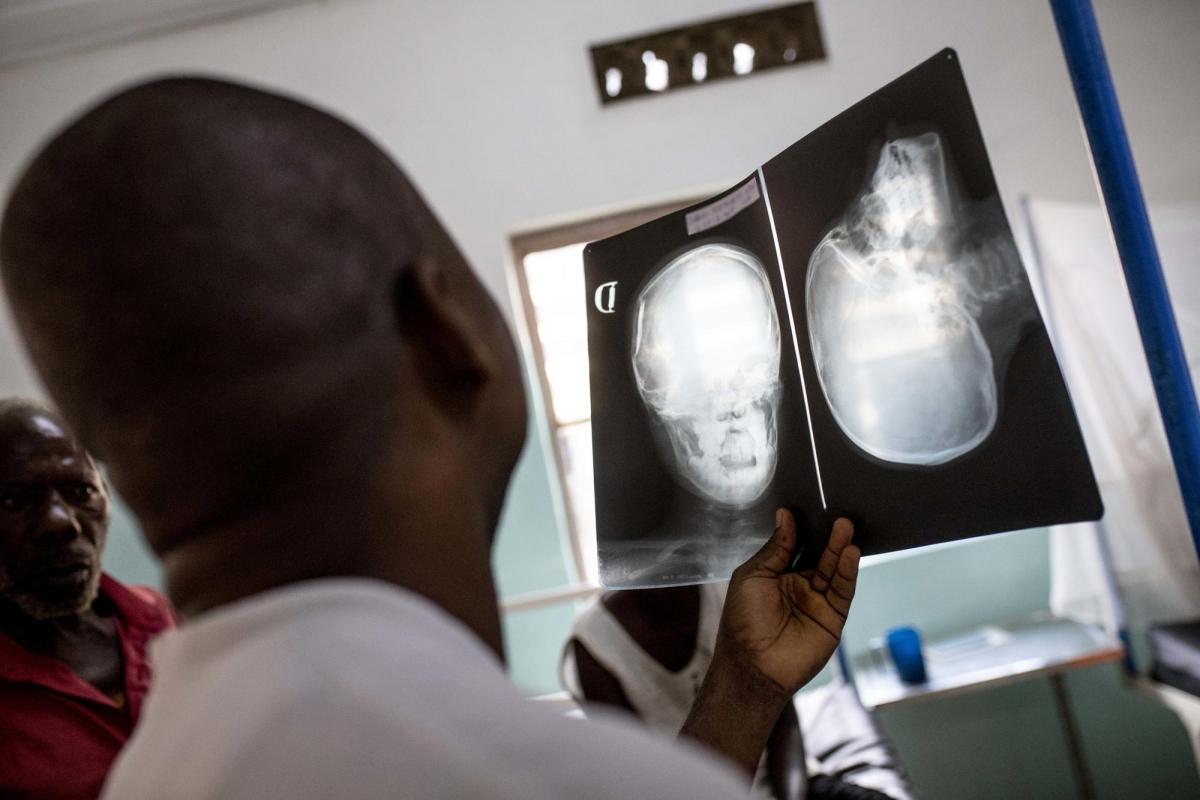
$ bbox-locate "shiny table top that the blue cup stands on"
[854,613,1123,709]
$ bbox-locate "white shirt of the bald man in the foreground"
[104,579,748,800]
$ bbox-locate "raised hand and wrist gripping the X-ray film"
[680,509,860,776]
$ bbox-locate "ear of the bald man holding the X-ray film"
[394,257,498,402]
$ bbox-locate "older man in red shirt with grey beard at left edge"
[0,399,174,799]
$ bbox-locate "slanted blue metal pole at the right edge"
[1050,0,1200,563]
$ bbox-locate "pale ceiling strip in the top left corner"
[0,0,314,68]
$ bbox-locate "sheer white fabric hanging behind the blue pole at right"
[1028,200,1200,630]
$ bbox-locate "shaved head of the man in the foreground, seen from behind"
[0,79,524,561]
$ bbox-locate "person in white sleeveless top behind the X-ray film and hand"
[560,583,913,800]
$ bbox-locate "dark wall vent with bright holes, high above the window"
[592,1,826,103]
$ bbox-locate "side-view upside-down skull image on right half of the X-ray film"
[805,133,1020,465]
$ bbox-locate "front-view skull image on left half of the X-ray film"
[632,243,781,507]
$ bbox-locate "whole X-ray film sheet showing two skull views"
[584,50,1103,588]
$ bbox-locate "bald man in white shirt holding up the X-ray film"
[0,78,859,800]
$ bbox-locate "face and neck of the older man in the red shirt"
[0,404,124,697]
